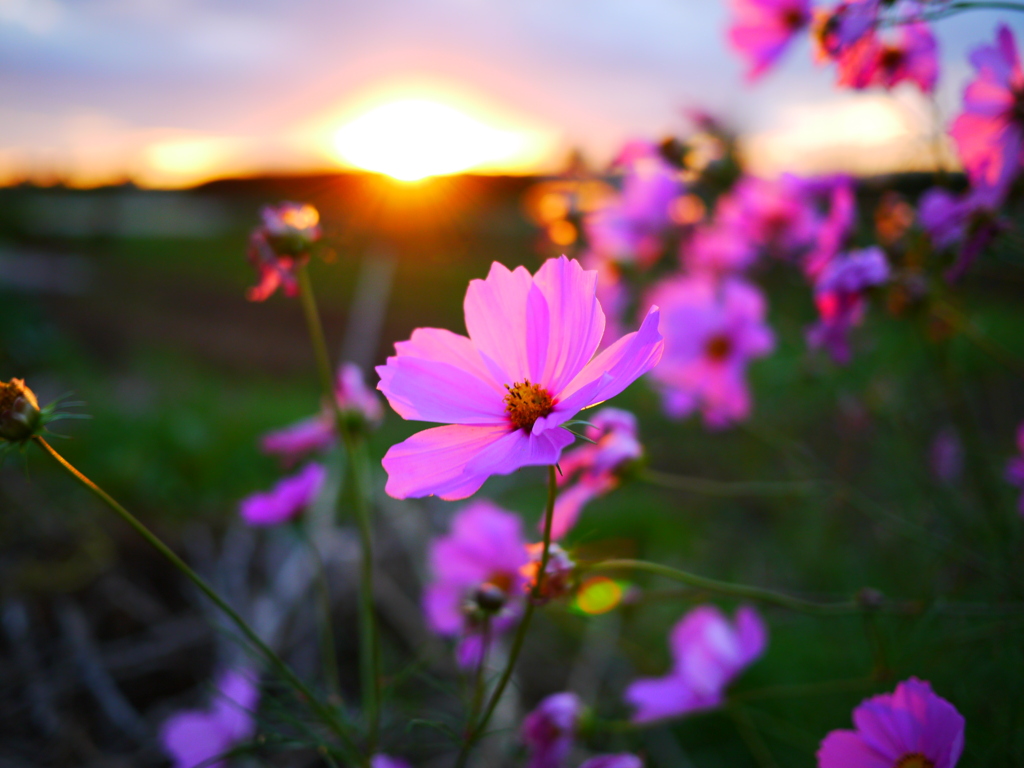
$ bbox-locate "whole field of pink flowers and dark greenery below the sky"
[0,0,1024,768]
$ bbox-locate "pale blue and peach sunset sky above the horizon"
[0,0,1024,186]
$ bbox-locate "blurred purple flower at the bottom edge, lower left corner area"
[160,670,259,768]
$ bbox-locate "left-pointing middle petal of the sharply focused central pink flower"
[378,355,507,424]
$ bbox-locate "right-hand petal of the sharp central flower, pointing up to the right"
[562,306,665,406]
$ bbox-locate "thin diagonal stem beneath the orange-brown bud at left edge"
[33,436,360,764]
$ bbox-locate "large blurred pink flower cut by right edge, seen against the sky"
[949,25,1024,195]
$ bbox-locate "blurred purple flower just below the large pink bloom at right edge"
[918,184,1006,282]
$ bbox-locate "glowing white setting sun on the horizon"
[334,98,524,181]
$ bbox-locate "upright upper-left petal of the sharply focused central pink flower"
[463,261,534,383]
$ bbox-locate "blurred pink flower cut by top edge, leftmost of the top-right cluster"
[729,0,811,81]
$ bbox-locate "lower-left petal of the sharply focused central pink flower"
[382,424,510,501]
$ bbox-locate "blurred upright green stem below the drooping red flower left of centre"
[298,264,381,755]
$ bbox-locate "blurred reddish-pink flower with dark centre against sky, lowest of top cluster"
[837,22,939,93]
